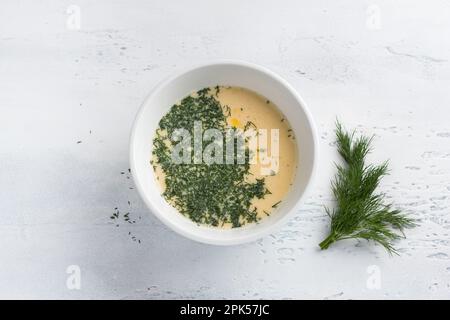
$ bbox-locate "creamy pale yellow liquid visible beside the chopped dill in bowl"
[155,86,298,228]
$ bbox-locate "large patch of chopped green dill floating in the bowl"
[153,88,268,227]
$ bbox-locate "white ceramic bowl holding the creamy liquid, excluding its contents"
[130,61,317,245]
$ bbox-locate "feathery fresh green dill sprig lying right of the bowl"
[319,122,416,254]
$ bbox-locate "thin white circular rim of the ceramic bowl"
[129,59,319,246]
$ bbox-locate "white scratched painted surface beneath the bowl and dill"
[0,0,450,299]
